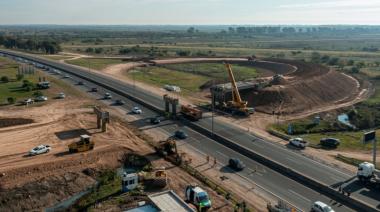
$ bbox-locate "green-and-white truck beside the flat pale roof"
[185,185,211,211]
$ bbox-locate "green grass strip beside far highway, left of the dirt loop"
[66,58,124,70]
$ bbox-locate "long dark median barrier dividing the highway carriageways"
[0,50,377,211]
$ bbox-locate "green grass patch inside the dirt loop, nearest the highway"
[127,67,210,94]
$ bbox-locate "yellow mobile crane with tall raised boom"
[223,63,255,116]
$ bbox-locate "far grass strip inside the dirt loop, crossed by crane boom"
[164,63,258,80]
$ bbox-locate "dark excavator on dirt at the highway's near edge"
[154,137,182,165]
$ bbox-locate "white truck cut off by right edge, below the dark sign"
[356,162,380,188]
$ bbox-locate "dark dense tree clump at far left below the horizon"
[0,36,62,54]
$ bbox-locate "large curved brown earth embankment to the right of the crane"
[243,60,360,114]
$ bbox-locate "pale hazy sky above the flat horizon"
[0,0,380,25]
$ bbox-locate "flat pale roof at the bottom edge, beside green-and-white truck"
[148,190,194,212]
